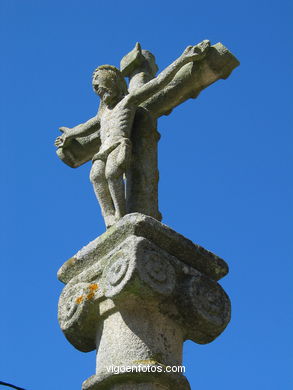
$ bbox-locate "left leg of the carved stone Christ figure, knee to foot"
[90,160,115,228]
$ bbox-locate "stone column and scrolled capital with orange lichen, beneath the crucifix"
[58,213,230,390]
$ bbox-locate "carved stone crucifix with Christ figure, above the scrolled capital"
[55,40,239,228]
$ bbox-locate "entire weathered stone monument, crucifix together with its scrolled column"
[56,41,239,390]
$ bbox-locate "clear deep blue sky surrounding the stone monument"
[0,0,292,390]
